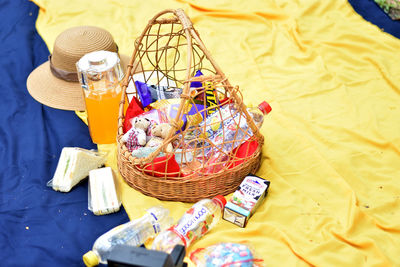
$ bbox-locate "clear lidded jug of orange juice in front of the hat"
[77,51,124,144]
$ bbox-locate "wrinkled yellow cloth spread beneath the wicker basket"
[34,0,400,266]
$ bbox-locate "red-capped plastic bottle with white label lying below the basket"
[152,195,226,253]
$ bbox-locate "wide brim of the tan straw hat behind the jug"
[26,54,130,111]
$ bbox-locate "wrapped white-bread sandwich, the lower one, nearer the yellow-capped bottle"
[88,167,121,215]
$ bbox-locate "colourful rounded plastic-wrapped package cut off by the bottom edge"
[189,243,263,267]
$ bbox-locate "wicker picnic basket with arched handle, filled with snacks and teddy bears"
[117,9,271,202]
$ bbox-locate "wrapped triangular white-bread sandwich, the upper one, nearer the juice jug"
[52,147,106,192]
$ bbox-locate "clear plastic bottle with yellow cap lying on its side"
[82,206,173,266]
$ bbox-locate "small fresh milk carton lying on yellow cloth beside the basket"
[223,174,270,227]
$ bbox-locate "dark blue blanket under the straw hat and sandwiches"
[0,0,129,266]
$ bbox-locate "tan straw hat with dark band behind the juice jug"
[26,26,135,110]
